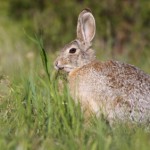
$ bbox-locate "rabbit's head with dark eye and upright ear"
[55,9,96,72]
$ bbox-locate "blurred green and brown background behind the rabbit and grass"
[0,0,150,74]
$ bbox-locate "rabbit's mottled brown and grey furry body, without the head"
[69,61,150,123]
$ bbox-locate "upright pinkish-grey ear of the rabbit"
[77,9,96,43]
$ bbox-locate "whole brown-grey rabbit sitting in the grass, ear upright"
[54,9,150,124]
